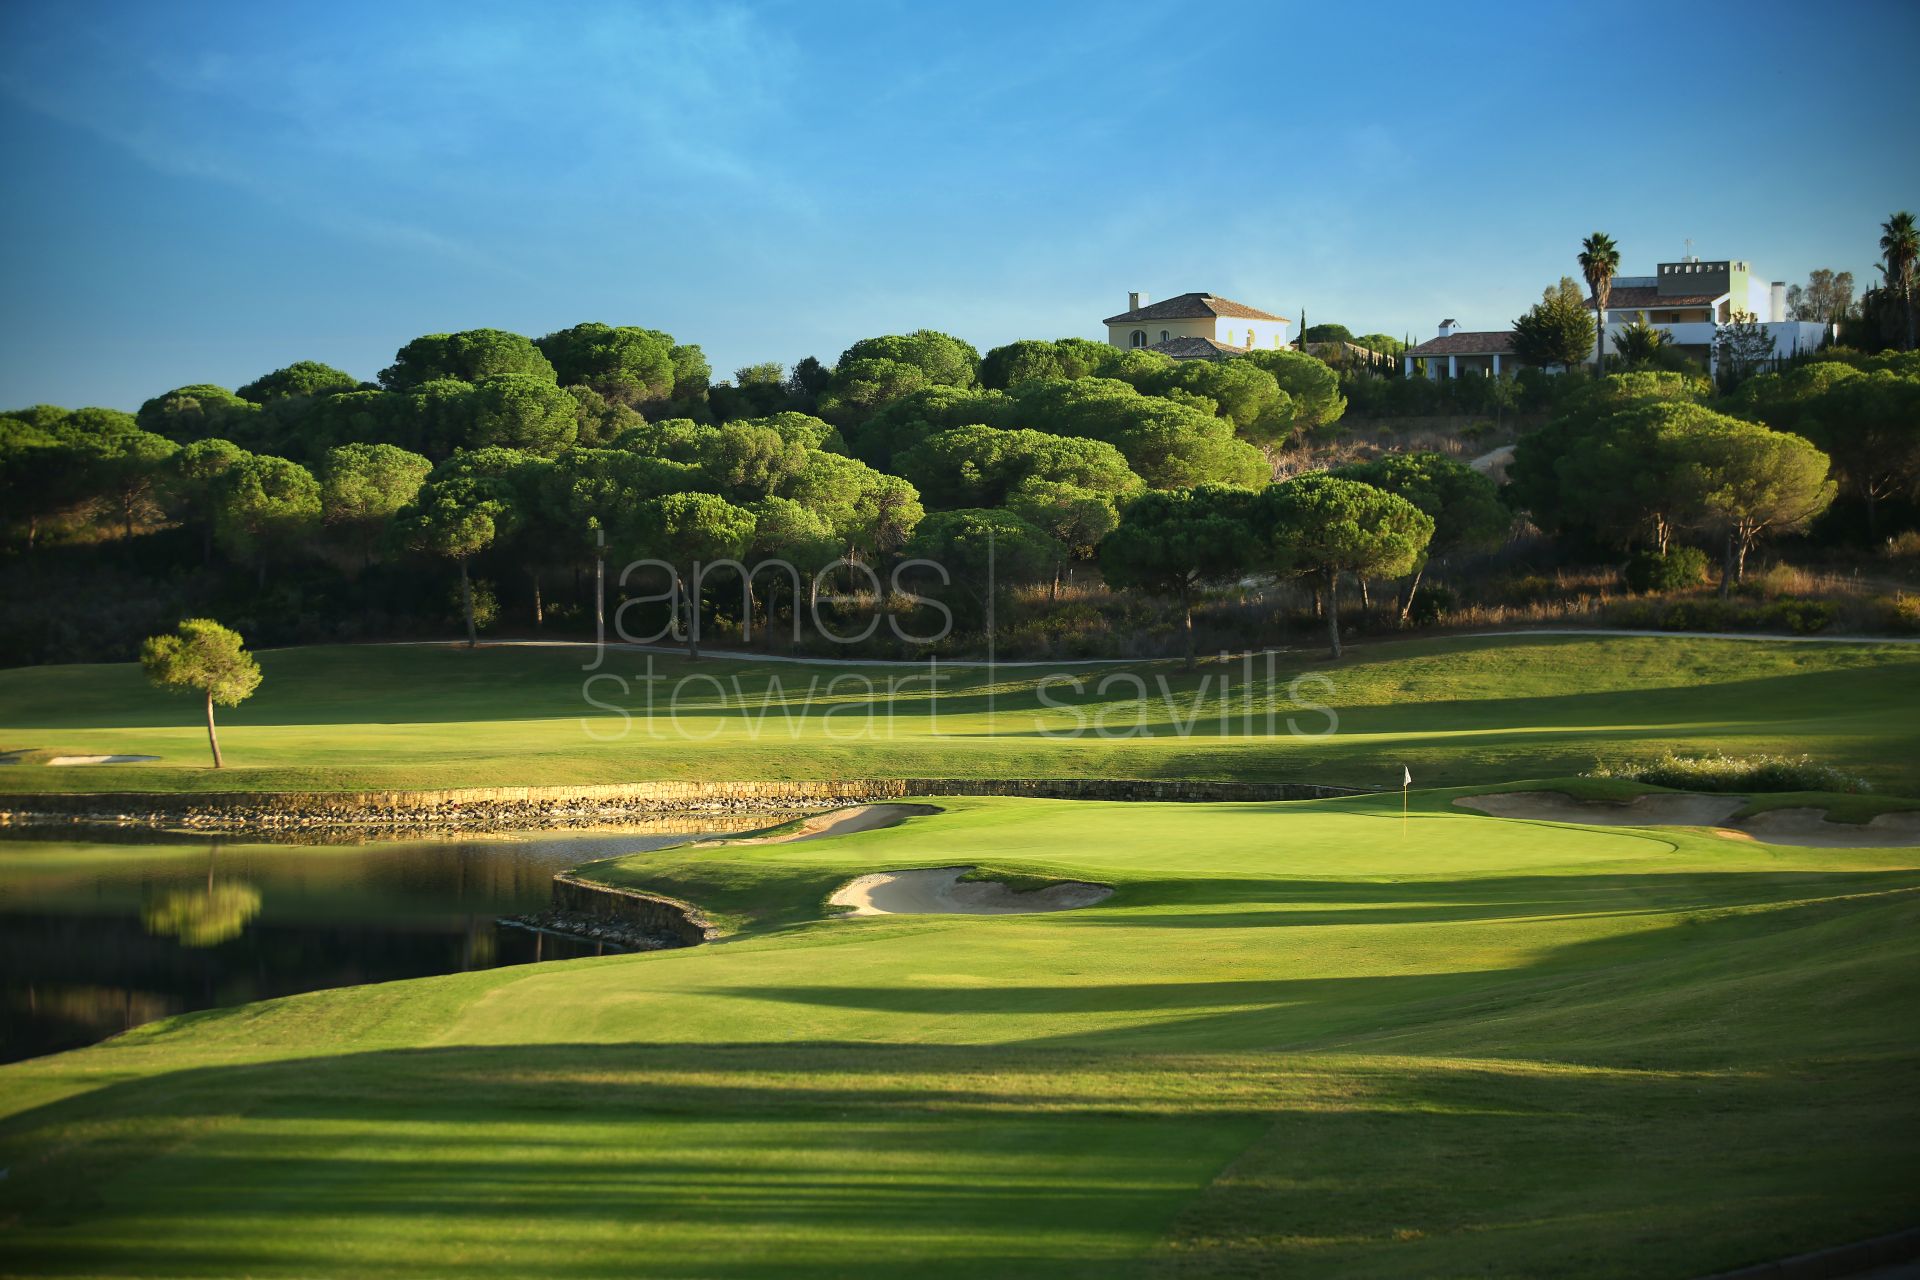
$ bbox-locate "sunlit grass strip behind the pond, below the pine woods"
[11,635,1920,794]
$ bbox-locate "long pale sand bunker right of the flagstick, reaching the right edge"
[1453,791,1920,848]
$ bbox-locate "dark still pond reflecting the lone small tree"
[0,814,776,1061]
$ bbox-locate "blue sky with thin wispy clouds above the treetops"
[0,0,1920,409]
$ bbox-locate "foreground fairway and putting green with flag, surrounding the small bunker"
[0,793,1920,1278]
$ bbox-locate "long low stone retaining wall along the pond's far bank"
[0,777,1361,829]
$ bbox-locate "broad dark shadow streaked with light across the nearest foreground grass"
[0,1028,1912,1280]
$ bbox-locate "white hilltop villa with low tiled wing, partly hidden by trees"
[1404,257,1832,378]
